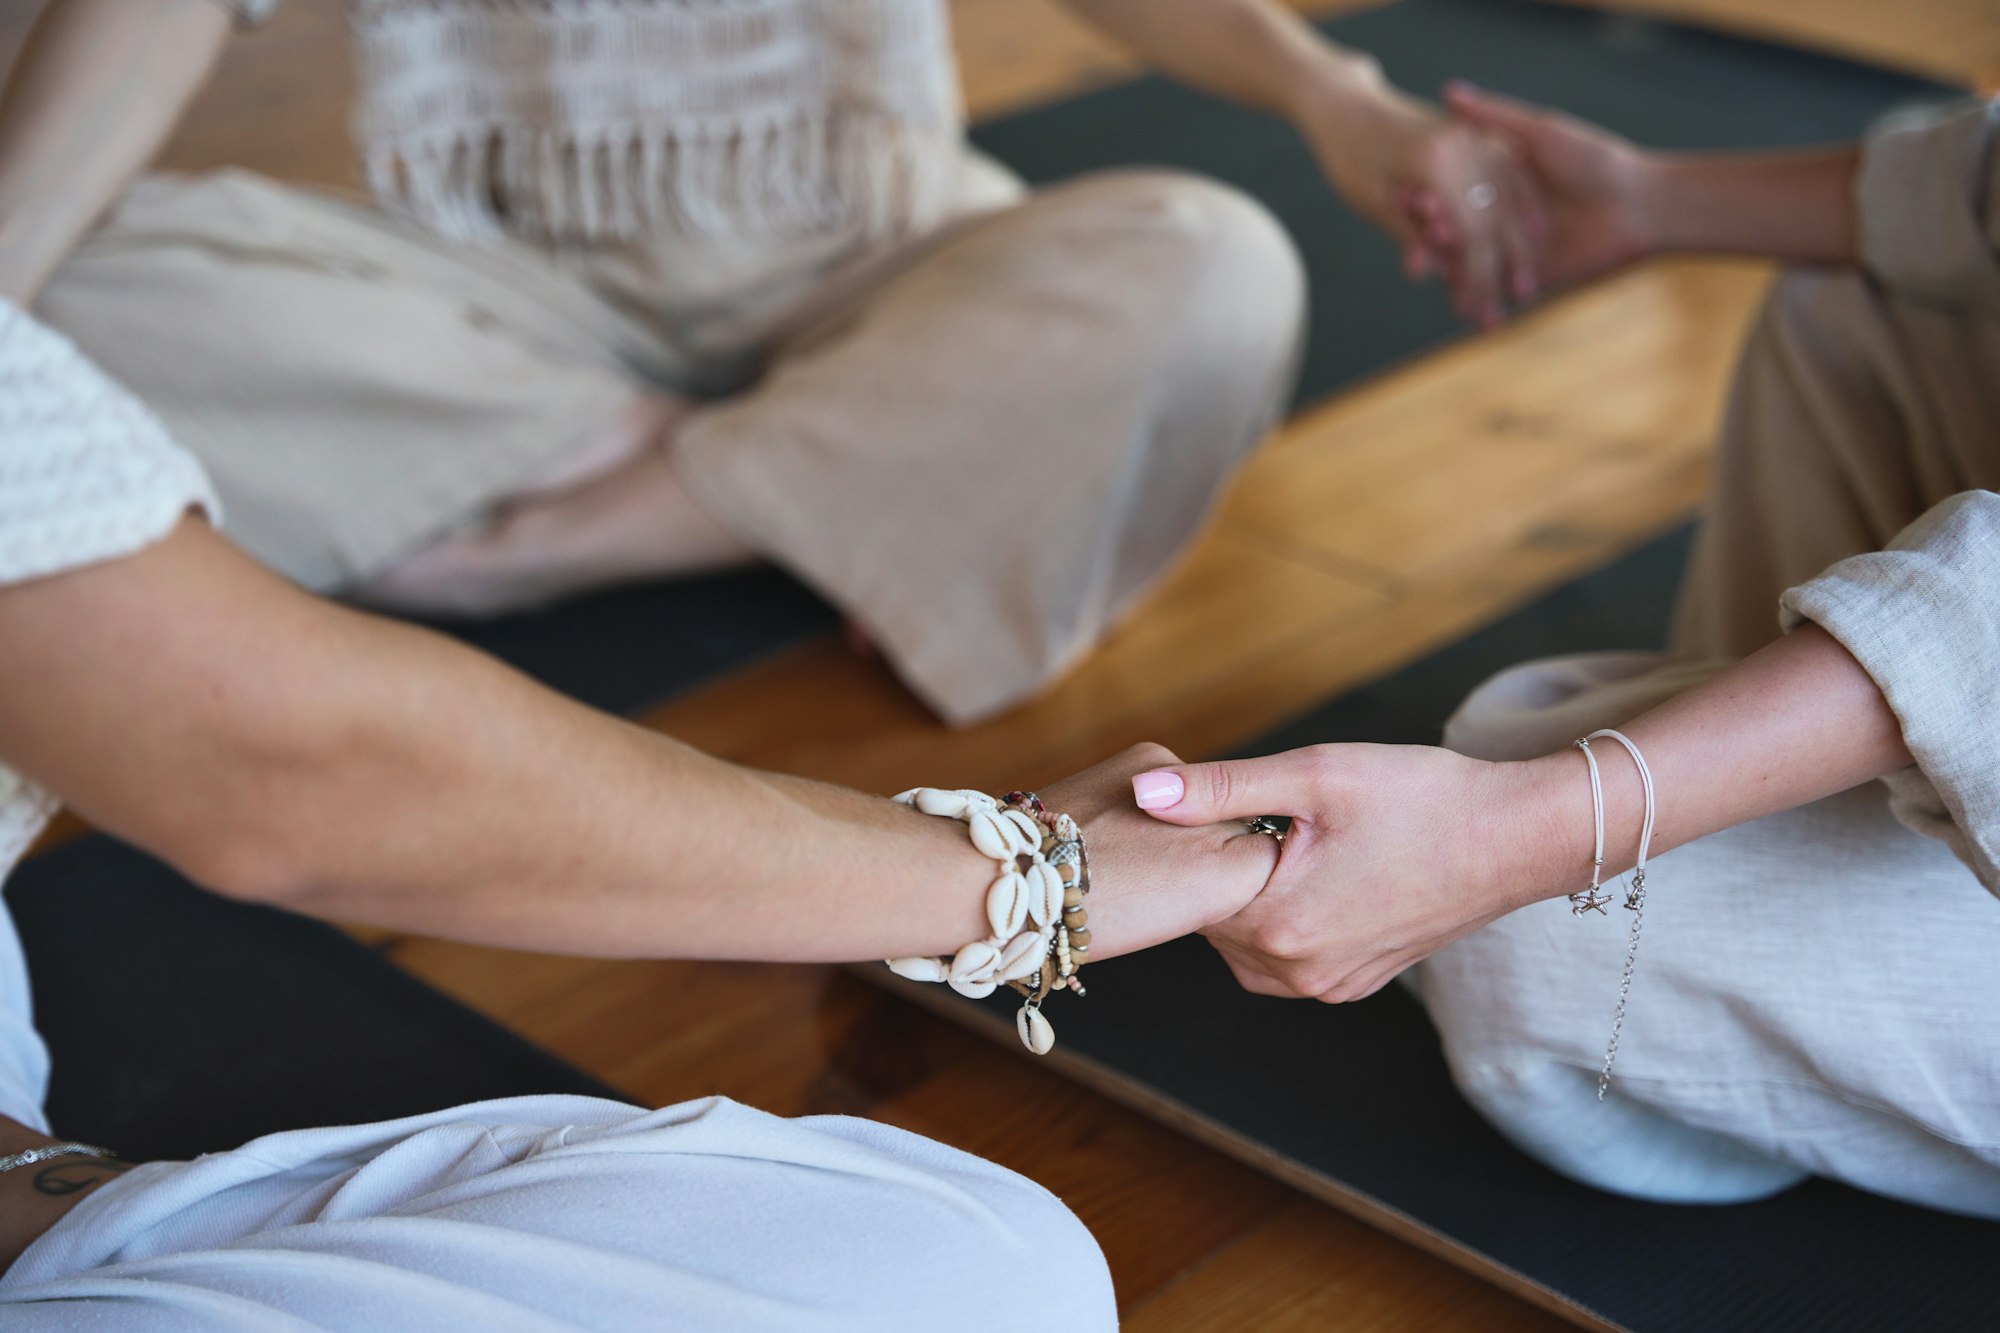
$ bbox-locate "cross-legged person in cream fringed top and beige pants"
[0,0,1532,723]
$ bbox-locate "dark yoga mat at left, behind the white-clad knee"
[19,837,620,1161]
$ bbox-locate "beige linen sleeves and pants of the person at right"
[1416,96,2000,1217]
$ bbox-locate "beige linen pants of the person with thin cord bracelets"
[1416,272,2000,1217]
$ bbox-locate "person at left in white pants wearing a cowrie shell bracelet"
[0,302,1274,1333]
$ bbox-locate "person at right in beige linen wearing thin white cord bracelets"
[1136,90,2000,1217]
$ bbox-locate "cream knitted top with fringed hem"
[224,0,964,240]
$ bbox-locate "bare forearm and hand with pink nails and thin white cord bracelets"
[1134,624,1910,1001]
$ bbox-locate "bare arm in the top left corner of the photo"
[0,0,230,306]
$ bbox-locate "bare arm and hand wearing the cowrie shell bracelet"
[0,520,1270,961]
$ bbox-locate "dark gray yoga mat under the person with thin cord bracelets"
[904,532,2000,1333]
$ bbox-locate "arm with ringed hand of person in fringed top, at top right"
[1068,0,1540,322]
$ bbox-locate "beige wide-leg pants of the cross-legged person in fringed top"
[40,166,1304,723]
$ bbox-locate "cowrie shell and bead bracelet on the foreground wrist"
[888,787,1090,1055]
